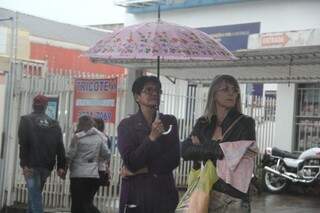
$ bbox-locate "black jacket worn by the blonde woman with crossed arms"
[181,109,255,199]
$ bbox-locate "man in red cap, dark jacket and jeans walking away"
[18,95,66,213]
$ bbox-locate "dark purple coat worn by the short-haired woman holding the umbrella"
[118,111,180,213]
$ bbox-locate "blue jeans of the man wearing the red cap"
[25,168,50,213]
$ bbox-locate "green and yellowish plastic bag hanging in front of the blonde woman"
[176,160,218,213]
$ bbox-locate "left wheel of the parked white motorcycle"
[263,164,288,193]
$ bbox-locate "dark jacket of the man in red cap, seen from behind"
[18,112,66,171]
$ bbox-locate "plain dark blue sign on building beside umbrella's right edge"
[198,22,260,51]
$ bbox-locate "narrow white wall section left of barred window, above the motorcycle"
[274,84,296,151]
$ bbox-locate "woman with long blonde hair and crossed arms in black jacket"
[181,75,257,213]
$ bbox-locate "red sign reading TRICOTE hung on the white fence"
[73,78,117,123]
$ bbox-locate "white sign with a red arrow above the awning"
[248,29,320,49]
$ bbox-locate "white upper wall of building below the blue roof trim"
[125,0,320,33]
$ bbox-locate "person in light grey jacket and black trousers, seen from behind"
[67,115,110,213]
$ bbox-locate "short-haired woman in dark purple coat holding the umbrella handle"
[118,76,180,213]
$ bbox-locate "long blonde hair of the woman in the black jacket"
[203,75,242,121]
